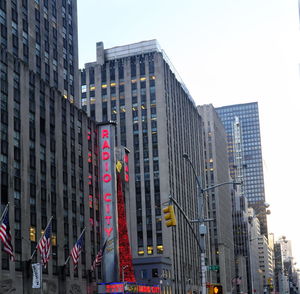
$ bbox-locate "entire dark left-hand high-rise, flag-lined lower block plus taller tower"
[0,0,100,293]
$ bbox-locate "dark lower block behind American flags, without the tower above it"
[0,66,100,293]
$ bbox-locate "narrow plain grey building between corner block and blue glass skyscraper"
[197,104,235,293]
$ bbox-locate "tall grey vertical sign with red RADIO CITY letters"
[98,123,119,283]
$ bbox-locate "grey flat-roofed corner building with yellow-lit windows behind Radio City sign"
[80,40,202,293]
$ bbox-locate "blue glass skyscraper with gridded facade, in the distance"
[216,102,268,237]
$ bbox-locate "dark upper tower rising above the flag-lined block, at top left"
[0,0,78,102]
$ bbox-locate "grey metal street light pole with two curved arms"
[182,153,241,294]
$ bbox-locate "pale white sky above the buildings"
[78,0,300,268]
